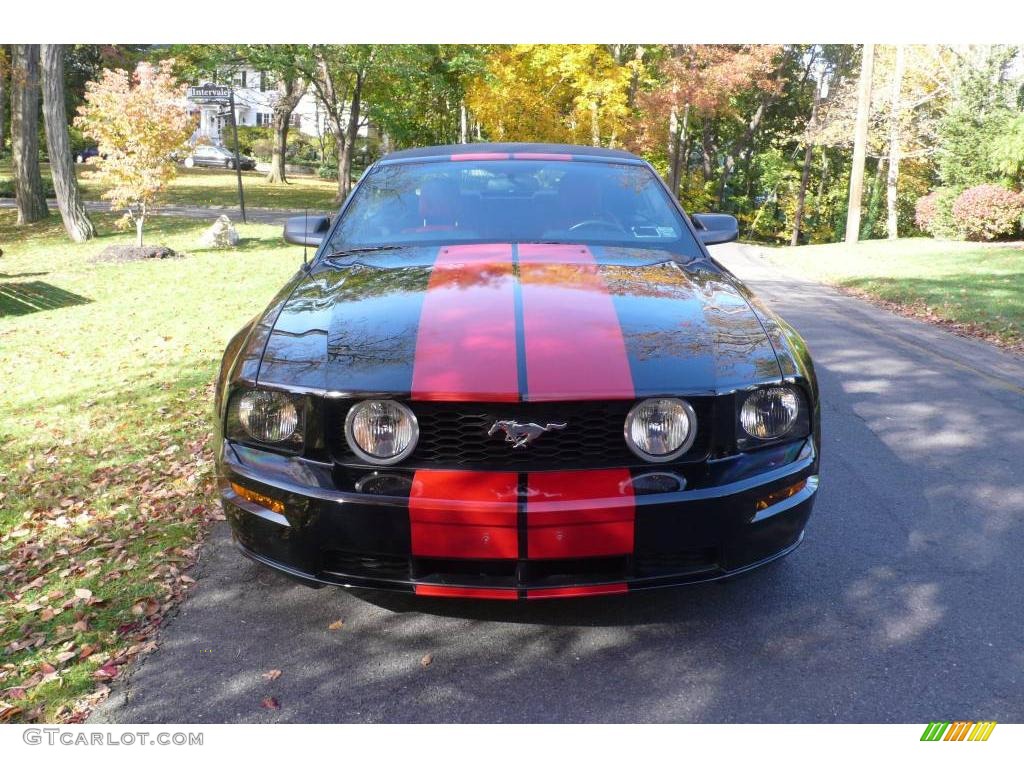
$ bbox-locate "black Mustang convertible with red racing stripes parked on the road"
[216,144,820,599]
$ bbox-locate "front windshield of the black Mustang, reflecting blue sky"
[328,160,699,257]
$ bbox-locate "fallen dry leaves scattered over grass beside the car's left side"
[0,388,222,722]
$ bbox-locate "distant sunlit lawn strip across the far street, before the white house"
[0,158,338,211]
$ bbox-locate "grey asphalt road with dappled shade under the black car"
[93,246,1024,724]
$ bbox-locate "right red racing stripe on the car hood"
[519,244,634,401]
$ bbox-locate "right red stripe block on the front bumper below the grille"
[526,469,636,560]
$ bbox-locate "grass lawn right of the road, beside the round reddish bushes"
[763,238,1024,348]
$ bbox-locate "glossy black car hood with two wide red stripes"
[258,244,780,401]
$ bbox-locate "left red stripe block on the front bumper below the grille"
[409,469,519,559]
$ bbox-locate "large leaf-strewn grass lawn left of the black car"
[0,210,302,722]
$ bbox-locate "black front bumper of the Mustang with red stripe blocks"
[217,438,818,599]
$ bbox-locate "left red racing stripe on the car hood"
[412,244,519,402]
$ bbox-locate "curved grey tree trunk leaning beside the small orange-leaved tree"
[40,45,96,243]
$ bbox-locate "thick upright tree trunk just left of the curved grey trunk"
[10,45,49,224]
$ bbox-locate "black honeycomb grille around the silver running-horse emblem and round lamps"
[331,399,711,471]
